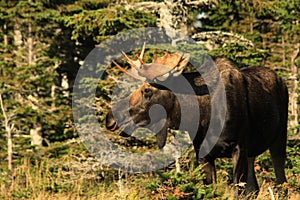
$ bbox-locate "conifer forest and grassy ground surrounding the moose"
[0,0,300,199]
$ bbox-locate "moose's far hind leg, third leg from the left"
[246,157,259,195]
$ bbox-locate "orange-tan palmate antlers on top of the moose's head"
[113,43,189,81]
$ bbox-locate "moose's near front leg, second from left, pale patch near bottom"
[232,145,248,197]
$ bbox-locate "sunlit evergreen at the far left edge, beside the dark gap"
[0,1,71,155]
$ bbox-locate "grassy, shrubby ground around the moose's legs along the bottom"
[0,135,300,200]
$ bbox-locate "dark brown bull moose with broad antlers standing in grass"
[106,46,288,195]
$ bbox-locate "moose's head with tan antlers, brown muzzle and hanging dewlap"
[106,44,189,148]
